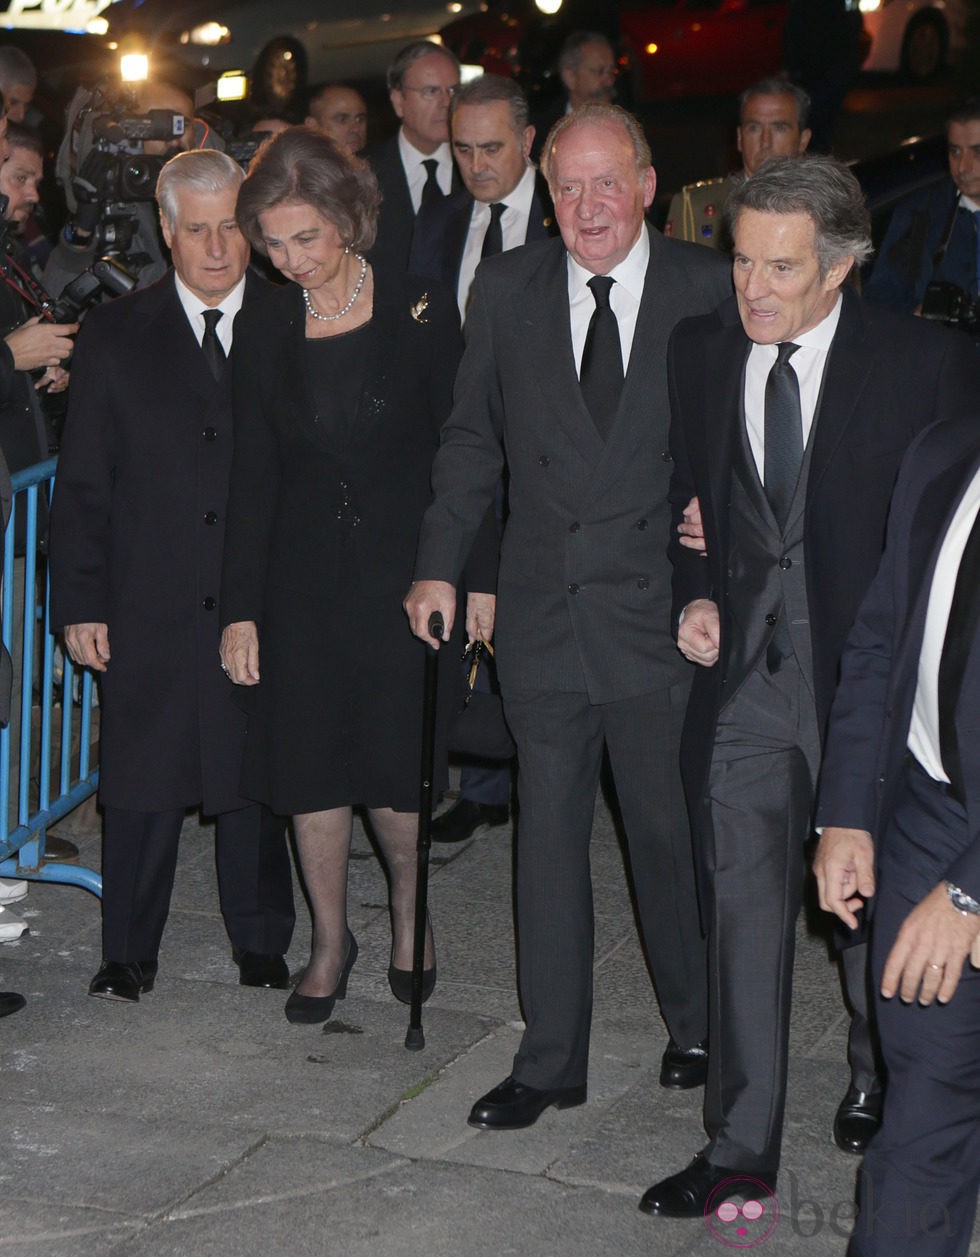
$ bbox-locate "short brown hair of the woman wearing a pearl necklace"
[236,127,381,253]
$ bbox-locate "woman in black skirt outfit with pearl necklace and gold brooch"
[221,127,493,1022]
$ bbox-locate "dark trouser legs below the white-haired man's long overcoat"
[102,803,295,962]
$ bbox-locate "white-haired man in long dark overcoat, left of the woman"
[50,150,294,1002]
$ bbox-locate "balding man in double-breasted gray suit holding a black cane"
[406,103,729,1129]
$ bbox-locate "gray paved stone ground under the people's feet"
[0,779,980,1257]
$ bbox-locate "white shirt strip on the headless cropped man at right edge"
[908,473,980,782]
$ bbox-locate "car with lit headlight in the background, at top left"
[104,0,479,109]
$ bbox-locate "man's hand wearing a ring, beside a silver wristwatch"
[881,882,980,1004]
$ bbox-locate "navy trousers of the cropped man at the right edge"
[848,766,980,1257]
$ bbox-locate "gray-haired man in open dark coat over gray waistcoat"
[641,156,977,1217]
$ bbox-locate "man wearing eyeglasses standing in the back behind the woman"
[364,39,461,270]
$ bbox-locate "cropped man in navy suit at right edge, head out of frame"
[814,414,980,1257]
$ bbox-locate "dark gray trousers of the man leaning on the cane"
[504,684,706,1087]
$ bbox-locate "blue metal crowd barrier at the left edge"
[0,459,102,895]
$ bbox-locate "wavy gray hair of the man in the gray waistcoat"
[725,153,872,278]
